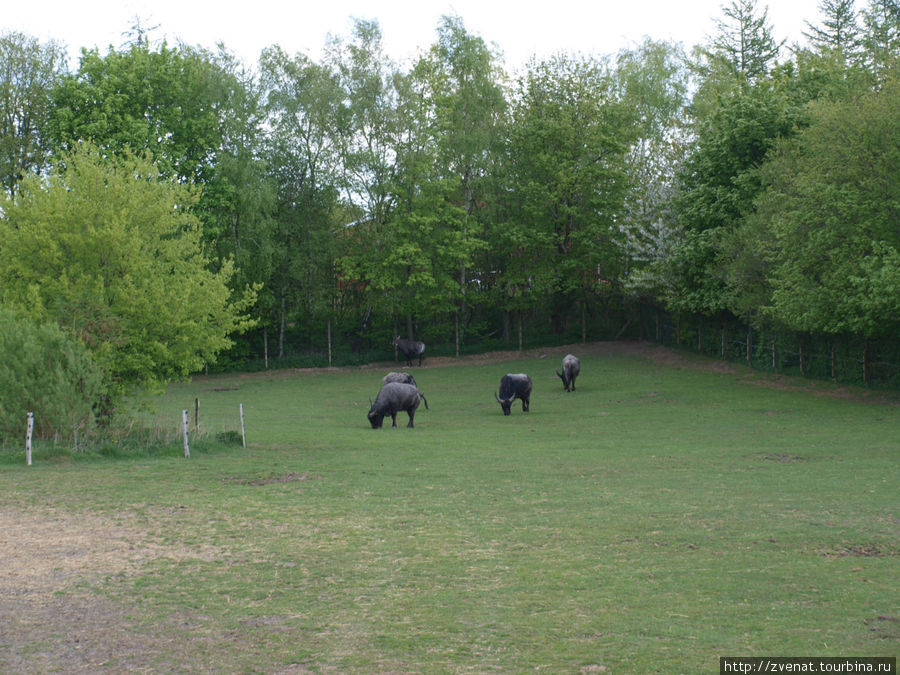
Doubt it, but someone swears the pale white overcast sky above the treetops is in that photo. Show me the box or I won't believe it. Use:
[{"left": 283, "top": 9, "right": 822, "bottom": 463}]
[{"left": 7, "top": 0, "right": 820, "bottom": 69}]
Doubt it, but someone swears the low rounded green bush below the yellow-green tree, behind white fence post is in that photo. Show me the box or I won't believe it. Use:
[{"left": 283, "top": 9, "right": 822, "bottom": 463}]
[{"left": 0, "top": 309, "right": 104, "bottom": 443}]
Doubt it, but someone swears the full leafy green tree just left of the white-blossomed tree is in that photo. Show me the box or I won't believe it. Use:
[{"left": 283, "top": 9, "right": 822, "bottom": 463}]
[{"left": 497, "top": 56, "right": 630, "bottom": 344}]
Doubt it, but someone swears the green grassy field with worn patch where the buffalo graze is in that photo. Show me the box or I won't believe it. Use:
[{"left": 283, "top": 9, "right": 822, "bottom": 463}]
[{"left": 0, "top": 344, "right": 900, "bottom": 673}]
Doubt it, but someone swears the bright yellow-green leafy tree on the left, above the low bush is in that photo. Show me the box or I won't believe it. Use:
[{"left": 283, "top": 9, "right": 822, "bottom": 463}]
[{"left": 0, "top": 144, "right": 254, "bottom": 391}]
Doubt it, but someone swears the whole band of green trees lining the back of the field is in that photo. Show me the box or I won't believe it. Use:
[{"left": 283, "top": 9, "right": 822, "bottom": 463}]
[{"left": 0, "top": 0, "right": 900, "bottom": 440}]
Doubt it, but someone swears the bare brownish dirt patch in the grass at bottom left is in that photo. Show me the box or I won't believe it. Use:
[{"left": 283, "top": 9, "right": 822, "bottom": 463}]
[{"left": 0, "top": 509, "right": 224, "bottom": 673}]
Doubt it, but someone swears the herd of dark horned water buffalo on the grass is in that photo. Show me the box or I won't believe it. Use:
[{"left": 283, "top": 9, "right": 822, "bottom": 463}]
[{"left": 368, "top": 337, "right": 581, "bottom": 429}]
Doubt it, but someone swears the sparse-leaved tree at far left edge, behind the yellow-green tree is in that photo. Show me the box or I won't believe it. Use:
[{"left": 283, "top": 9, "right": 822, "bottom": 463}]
[{"left": 0, "top": 32, "right": 66, "bottom": 195}]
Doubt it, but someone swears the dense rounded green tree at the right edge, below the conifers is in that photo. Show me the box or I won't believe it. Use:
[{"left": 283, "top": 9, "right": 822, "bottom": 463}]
[{"left": 759, "top": 70, "right": 900, "bottom": 338}]
